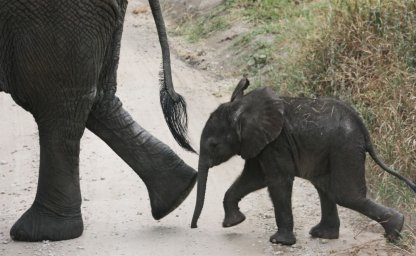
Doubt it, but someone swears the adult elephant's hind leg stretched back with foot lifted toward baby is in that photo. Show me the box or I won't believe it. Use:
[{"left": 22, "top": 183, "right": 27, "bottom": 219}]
[{"left": 87, "top": 94, "right": 196, "bottom": 219}]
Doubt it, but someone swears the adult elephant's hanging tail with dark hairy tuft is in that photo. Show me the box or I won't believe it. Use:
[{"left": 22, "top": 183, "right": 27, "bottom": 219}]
[{"left": 149, "top": 0, "right": 196, "bottom": 153}]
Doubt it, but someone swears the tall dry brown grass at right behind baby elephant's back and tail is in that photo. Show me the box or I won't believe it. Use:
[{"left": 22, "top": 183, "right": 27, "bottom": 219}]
[{"left": 303, "top": 0, "right": 416, "bottom": 248}]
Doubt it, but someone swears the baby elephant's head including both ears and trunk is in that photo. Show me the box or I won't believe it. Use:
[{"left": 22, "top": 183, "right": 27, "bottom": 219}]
[{"left": 191, "top": 78, "right": 283, "bottom": 228}]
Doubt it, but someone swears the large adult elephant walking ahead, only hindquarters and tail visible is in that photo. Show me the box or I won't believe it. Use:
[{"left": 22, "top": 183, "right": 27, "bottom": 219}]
[{"left": 0, "top": 0, "right": 196, "bottom": 241}]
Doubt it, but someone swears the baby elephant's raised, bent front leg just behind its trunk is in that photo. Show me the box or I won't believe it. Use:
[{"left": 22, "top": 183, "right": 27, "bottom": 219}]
[{"left": 222, "top": 159, "right": 266, "bottom": 227}]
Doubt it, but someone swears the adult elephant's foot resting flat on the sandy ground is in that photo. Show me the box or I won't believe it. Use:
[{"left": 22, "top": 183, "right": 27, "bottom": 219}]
[{"left": 10, "top": 202, "right": 84, "bottom": 242}]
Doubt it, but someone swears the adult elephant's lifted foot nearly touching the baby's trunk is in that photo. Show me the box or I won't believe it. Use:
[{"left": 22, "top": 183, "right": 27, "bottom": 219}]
[{"left": 145, "top": 162, "right": 197, "bottom": 220}]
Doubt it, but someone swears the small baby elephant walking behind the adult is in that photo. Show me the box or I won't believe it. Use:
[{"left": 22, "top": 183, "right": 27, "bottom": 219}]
[{"left": 191, "top": 78, "right": 416, "bottom": 245}]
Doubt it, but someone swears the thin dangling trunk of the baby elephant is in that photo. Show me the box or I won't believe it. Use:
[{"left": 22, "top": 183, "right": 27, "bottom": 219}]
[{"left": 191, "top": 160, "right": 208, "bottom": 228}]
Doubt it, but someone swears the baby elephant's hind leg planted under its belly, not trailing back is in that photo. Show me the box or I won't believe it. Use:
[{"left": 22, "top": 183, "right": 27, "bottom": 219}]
[{"left": 309, "top": 186, "right": 340, "bottom": 239}]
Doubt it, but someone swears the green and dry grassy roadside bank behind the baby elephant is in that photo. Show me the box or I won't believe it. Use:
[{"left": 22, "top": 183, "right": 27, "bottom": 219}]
[{"left": 178, "top": 0, "right": 416, "bottom": 252}]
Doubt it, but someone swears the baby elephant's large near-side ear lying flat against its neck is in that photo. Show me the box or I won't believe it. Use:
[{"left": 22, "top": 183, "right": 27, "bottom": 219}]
[{"left": 236, "top": 87, "right": 284, "bottom": 159}]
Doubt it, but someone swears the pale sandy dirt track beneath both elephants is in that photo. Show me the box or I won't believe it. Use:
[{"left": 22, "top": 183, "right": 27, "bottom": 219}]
[{"left": 0, "top": 1, "right": 405, "bottom": 256}]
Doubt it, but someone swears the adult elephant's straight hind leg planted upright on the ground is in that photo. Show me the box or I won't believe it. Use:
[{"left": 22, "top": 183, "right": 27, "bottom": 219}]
[{"left": 10, "top": 97, "right": 92, "bottom": 241}]
